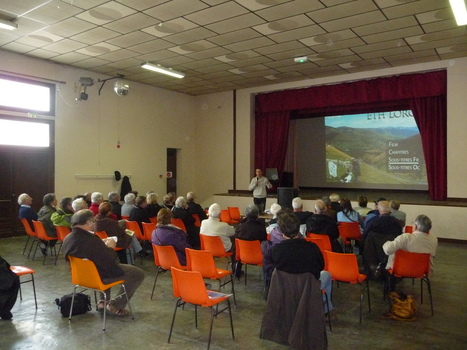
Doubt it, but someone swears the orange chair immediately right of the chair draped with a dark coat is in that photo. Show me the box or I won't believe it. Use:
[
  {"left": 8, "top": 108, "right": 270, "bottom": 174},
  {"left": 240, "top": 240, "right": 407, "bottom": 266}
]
[{"left": 324, "top": 250, "right": 371, "bottom": 323}]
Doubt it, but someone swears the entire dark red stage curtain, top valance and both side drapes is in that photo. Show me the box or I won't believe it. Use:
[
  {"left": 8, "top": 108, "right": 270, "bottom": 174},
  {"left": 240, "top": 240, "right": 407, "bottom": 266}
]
[{"left": 255, "top": 70, "right": 447, "bottom": 200}]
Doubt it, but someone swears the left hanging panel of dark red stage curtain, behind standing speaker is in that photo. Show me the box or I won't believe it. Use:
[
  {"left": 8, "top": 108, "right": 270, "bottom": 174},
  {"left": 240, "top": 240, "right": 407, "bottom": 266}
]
[{"left": 255, "top": 111, "right": 290, "bottom": 176}]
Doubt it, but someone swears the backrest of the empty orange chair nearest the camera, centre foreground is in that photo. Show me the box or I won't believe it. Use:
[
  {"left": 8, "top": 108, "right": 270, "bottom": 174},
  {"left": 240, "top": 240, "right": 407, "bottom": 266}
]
[{"left": 171, "top": 267, "right": 208, "bottom": 305}]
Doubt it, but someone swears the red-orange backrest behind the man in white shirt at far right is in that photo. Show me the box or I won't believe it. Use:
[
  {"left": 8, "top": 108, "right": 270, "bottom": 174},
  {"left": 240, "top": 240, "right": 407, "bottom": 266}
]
[{"left": 392, "top": 250, "right": 430, "bottom": 278}]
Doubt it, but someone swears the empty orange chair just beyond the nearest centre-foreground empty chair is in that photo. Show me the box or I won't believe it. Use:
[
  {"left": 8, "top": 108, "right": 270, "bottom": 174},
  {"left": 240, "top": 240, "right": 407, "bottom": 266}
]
[{"left": 185, "top": 248, "right": 237, "bottom": 306}]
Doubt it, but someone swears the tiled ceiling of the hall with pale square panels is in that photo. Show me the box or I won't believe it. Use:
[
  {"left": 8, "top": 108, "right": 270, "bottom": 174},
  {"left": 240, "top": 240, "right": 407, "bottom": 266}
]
[{"left": 0, "top": 0, "right": 467, "bottom": 95}]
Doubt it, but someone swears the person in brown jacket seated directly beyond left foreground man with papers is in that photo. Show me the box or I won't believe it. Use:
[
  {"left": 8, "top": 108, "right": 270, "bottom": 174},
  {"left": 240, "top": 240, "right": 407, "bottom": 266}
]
[{"left": 95, "top": 202, "right": 142, "bottom": 264}]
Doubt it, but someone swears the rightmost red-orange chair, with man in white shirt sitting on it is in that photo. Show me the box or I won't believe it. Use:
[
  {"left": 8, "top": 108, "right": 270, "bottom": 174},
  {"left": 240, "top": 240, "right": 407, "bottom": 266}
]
[{"left": 384, "top": 250, "right": 435, "bottom": 316}]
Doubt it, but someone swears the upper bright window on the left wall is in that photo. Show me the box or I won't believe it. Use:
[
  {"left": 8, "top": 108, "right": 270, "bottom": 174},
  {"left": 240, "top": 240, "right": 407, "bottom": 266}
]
[{"left": 0, "top": 75, "right": 55, "bottom": 116}]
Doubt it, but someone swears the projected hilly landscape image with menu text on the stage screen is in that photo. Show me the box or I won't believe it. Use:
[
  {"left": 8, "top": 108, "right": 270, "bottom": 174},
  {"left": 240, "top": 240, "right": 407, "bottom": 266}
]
[{"left": 325, "top": 110, "right": 427, "bottom": 188}]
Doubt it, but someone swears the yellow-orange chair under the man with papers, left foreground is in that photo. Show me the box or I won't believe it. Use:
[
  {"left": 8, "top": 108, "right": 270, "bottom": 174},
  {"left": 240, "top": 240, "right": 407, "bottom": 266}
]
[{"left": 68, "top": 255, "right": 135, "bottom": 332}]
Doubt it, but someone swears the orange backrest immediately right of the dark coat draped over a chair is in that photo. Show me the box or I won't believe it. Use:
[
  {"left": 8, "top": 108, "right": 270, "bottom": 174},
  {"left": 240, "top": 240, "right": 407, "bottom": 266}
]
[{"left": 324, "top": 250, "right": 360, "bottom": 283}]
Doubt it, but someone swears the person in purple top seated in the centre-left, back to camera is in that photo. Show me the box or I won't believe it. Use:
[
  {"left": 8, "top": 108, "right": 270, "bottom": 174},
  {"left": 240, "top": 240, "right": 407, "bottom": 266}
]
[{"left": 152, "top": 208, "right": 191, "bottom": 266}]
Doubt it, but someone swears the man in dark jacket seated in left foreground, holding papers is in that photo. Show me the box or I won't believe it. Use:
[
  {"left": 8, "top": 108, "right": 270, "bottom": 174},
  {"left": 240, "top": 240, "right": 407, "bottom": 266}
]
[{"left": 63, "top": 209, "right": 144, "bottom": 316}]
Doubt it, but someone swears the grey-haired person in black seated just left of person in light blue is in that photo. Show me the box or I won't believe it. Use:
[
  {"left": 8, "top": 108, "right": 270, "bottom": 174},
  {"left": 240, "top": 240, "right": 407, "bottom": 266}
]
[{"left": 306, "top": 199, "right": 343, "bottom": 253}]
